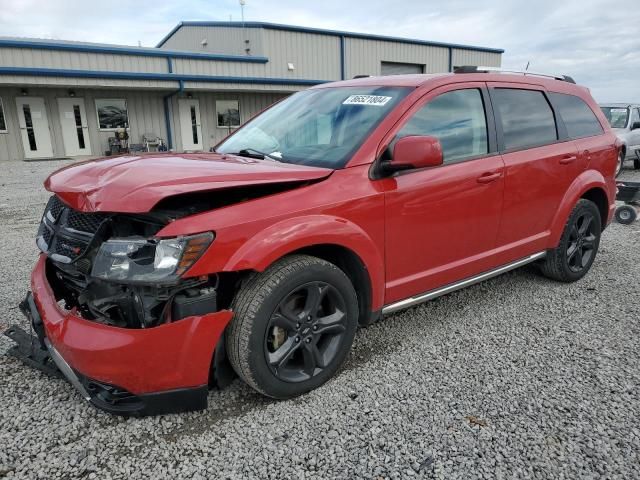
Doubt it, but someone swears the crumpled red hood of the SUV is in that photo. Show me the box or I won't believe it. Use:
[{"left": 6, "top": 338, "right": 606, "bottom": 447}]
[{"left": 44, "top": 153, "right": 333, "bottom": 213}]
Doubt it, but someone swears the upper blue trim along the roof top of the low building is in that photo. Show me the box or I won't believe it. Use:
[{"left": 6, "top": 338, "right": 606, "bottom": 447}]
[{"left": 0, "top": 39, "right": 269, "bottom": 63}]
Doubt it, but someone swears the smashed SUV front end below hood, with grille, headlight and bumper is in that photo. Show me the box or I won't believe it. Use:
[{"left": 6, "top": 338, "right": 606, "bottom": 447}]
[{"left": 5, "top": 195, "right": 239, "bottom": 415}]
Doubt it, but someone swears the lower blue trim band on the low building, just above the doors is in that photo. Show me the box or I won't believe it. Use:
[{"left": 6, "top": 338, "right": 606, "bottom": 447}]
[{"left": 0, "top": 67, "right": 333, "bottom": 86}]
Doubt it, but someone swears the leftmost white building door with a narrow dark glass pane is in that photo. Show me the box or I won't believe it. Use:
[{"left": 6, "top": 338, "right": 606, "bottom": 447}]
[{"left": 16, "top": 97, "right": 53, "bottom": 158}]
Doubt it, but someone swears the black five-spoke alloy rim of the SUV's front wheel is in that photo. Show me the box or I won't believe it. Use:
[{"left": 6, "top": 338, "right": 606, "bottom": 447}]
[{"left": 265, "top": 282, "right": 347, "bottom": 382}]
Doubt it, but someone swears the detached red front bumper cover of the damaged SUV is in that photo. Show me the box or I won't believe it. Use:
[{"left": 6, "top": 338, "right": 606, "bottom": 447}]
[{"left": 31, "top": 255, "right": 232, "bottom": 394}]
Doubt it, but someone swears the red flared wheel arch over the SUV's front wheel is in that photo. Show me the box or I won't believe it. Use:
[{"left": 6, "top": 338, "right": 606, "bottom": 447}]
[{"left": 222, "top": 215, "right": 384, "bottom": 311}]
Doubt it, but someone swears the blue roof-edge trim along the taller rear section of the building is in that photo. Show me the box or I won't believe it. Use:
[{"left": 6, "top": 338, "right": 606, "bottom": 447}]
[{"left": 156, "top": 21, "right": 504, "bottom": 53}]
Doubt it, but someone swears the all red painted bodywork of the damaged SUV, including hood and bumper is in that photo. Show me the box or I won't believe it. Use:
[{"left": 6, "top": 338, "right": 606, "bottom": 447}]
[{"left": 37, "top": 70, "right": 619, "bottom": 393}]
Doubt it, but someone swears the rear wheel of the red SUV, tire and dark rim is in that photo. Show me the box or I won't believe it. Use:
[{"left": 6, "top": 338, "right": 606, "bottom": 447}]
[{"left": 541, "top": 198, "right": 602, "bottom": 282}]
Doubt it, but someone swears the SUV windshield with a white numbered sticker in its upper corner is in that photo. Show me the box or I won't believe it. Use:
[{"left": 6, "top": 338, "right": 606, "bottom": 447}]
[{"left": 216, "top": 86, "right": 410, "bottom": 169}]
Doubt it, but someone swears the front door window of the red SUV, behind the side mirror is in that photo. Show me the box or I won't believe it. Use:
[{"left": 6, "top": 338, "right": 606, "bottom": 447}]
[{"left": 397, "top": 89, "right": 488, "bottom": 163}]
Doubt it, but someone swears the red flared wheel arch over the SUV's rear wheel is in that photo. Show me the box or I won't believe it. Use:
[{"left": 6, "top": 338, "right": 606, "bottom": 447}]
[{"left": 549, "top": 170, "right": 615, "bottom": 248}]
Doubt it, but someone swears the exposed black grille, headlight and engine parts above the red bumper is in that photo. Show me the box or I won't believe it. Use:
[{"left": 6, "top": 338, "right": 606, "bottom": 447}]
[{"left": 37, "top": 195, "right": 224, "bottom": 328}]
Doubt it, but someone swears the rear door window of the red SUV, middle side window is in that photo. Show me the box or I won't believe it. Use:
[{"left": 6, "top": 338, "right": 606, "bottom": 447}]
[{"left": 493, "top": 88, "right": 558, "bottom": 150}]
